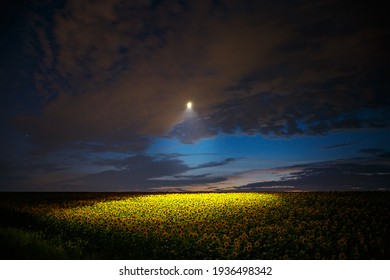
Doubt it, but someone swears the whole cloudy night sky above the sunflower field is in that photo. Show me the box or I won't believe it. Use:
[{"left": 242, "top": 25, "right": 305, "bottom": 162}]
[{"left": 0, "top": 0, "right": 390, "bottom": 191}]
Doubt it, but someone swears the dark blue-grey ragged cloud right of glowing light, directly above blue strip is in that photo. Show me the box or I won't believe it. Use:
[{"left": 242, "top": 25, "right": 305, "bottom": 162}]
[{"left": 184, "top": 80, "right": 390, "bottom": 142}]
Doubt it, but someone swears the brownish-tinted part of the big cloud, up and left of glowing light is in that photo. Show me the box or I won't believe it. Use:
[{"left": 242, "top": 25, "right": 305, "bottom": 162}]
[{"left": 17, "top": 1, "right": 286, "bottom": 149}]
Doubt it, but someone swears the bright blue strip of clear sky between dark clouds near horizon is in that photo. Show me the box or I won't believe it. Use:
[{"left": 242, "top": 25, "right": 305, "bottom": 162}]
[{"left": 147, "top": 131, "right": 390, "bottom": 189}]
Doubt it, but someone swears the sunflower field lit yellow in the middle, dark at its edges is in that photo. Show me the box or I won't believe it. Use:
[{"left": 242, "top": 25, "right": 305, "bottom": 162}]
[{"left": 0, "top": 192, "right": 390, "bottom": 259}]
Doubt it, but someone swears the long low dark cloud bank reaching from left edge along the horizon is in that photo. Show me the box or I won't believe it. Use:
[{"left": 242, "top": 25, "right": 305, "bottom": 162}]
[{"left": 0, "top": 150, "right": 237, "bottom": 191}]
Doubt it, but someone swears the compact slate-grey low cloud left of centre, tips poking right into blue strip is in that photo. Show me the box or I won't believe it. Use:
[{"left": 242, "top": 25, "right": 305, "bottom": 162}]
[{"left": 65, "top": 155, "right": 235, "bottom": 191}]
